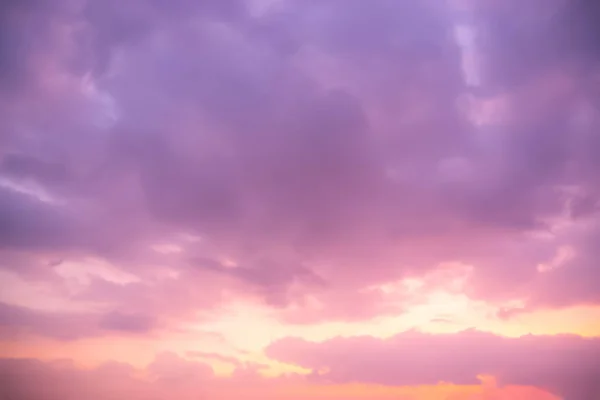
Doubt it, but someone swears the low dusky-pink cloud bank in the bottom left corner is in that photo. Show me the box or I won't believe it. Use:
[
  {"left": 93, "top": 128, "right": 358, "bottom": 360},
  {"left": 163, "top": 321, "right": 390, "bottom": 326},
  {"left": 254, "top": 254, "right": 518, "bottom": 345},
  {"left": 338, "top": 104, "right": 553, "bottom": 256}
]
[{"left": 0, "top": 352, "right": 302, "bottom": 400}]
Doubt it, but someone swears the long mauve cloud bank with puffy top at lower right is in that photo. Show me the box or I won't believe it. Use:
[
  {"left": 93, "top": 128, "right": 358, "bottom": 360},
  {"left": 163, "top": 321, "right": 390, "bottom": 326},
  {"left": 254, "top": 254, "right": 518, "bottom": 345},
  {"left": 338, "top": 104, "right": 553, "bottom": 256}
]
[{"left": 267, "top": 331, "right": 600, "bottom": 400}]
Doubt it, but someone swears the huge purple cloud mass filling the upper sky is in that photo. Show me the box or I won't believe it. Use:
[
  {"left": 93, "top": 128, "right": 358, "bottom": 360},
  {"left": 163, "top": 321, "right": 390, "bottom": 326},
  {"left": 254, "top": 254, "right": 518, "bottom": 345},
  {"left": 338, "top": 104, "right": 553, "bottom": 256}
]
[{"left": 0, "top": 0, "right": 599, "bottom": 331}]
